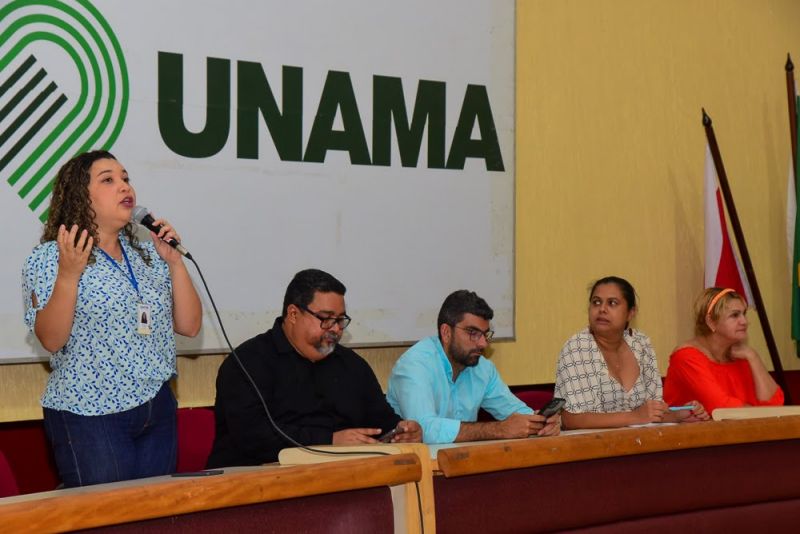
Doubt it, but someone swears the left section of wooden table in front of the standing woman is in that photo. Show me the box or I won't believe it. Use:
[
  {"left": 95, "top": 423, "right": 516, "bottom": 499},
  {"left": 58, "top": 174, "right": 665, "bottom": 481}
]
[{"left": 0, "top": 454, "right": 421, "bottom": 533}]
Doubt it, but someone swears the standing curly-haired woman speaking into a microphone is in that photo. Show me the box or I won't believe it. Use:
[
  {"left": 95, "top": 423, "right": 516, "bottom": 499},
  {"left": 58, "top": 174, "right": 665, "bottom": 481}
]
[{"left": 22, "top": 151, "right": 202, "bottom": 487}]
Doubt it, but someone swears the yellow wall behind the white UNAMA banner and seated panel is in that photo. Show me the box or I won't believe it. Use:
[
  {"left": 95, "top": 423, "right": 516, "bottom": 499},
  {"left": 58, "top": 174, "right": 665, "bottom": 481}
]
[{"left": 0, "top": 0, "right": 800, "bottom": 421}]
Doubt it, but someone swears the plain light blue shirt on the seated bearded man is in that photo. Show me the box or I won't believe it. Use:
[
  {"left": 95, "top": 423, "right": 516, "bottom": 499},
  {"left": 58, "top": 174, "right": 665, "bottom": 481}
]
[{"left": 386, "top": 336, "right": 533, "bottom": 443}]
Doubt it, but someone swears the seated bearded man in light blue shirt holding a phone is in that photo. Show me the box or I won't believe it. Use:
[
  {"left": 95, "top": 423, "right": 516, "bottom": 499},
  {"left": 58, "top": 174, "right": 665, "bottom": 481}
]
[{"left": 387, "top": 289, "right": 561, "bottom": 443}]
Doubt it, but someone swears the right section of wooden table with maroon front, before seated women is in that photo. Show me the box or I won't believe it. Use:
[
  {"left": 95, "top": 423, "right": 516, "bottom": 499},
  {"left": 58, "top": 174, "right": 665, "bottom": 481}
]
[{"left": 434, "top": 416, "right": 800, "bottom": 533}]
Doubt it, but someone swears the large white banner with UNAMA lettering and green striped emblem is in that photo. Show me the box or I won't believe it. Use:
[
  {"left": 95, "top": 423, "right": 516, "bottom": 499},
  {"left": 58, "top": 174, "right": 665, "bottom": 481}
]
[{"left": 0, "top": 0, "right": 515, "bottom": 362}]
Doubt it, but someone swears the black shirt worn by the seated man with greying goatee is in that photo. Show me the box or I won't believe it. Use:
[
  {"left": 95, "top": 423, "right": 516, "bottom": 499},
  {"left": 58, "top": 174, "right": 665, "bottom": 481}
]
[{"left": 208, "top": 317, "right": 401, "bottom": 467}]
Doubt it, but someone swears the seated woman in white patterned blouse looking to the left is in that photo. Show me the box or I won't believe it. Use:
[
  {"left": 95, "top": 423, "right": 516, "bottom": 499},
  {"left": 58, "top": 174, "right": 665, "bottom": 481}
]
[{"left": 555, "top": 276, "right": 708, "bottom": 428}]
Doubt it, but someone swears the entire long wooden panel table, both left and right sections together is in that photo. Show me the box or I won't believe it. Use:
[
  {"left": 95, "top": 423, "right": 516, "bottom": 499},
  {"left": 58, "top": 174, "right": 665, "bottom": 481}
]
[{"left": 6, "top": 416, "right": 800, "bottom": 534}]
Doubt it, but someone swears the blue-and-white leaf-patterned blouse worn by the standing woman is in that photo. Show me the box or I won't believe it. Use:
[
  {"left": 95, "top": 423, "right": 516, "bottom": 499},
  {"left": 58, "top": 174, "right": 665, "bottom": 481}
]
[{"left": 22, "top": 233, "right": 175, "bottom": 415}]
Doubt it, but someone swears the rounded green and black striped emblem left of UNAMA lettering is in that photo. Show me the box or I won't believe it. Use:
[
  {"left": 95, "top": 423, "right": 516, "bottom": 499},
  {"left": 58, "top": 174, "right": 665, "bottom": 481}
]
[{"left": 0, "top": 0, "right": 129, "bottom": 221}]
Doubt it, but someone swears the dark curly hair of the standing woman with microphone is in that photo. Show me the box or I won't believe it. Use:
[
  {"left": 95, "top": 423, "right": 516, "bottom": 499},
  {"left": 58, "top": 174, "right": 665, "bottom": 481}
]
[{"left": 41, "top": 150, "right": 150, "bottom": 265}]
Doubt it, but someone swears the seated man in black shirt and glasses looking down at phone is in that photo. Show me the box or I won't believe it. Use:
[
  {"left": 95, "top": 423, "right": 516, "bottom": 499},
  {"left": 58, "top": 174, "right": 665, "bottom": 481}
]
[{"left": 208, "top": 269, "right": 422, "bottom": 467}]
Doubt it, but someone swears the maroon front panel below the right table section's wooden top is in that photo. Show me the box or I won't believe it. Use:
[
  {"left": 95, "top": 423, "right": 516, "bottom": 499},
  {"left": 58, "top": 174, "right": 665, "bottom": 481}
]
[{"left": 434, "top": 439, "right": 800, "bottom": 534}]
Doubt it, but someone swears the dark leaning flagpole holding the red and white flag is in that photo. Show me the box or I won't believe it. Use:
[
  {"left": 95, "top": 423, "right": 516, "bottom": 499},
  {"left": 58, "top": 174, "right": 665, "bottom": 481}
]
[{"left": 703, "top": 109, "right": 792, "bottom": 404}]
